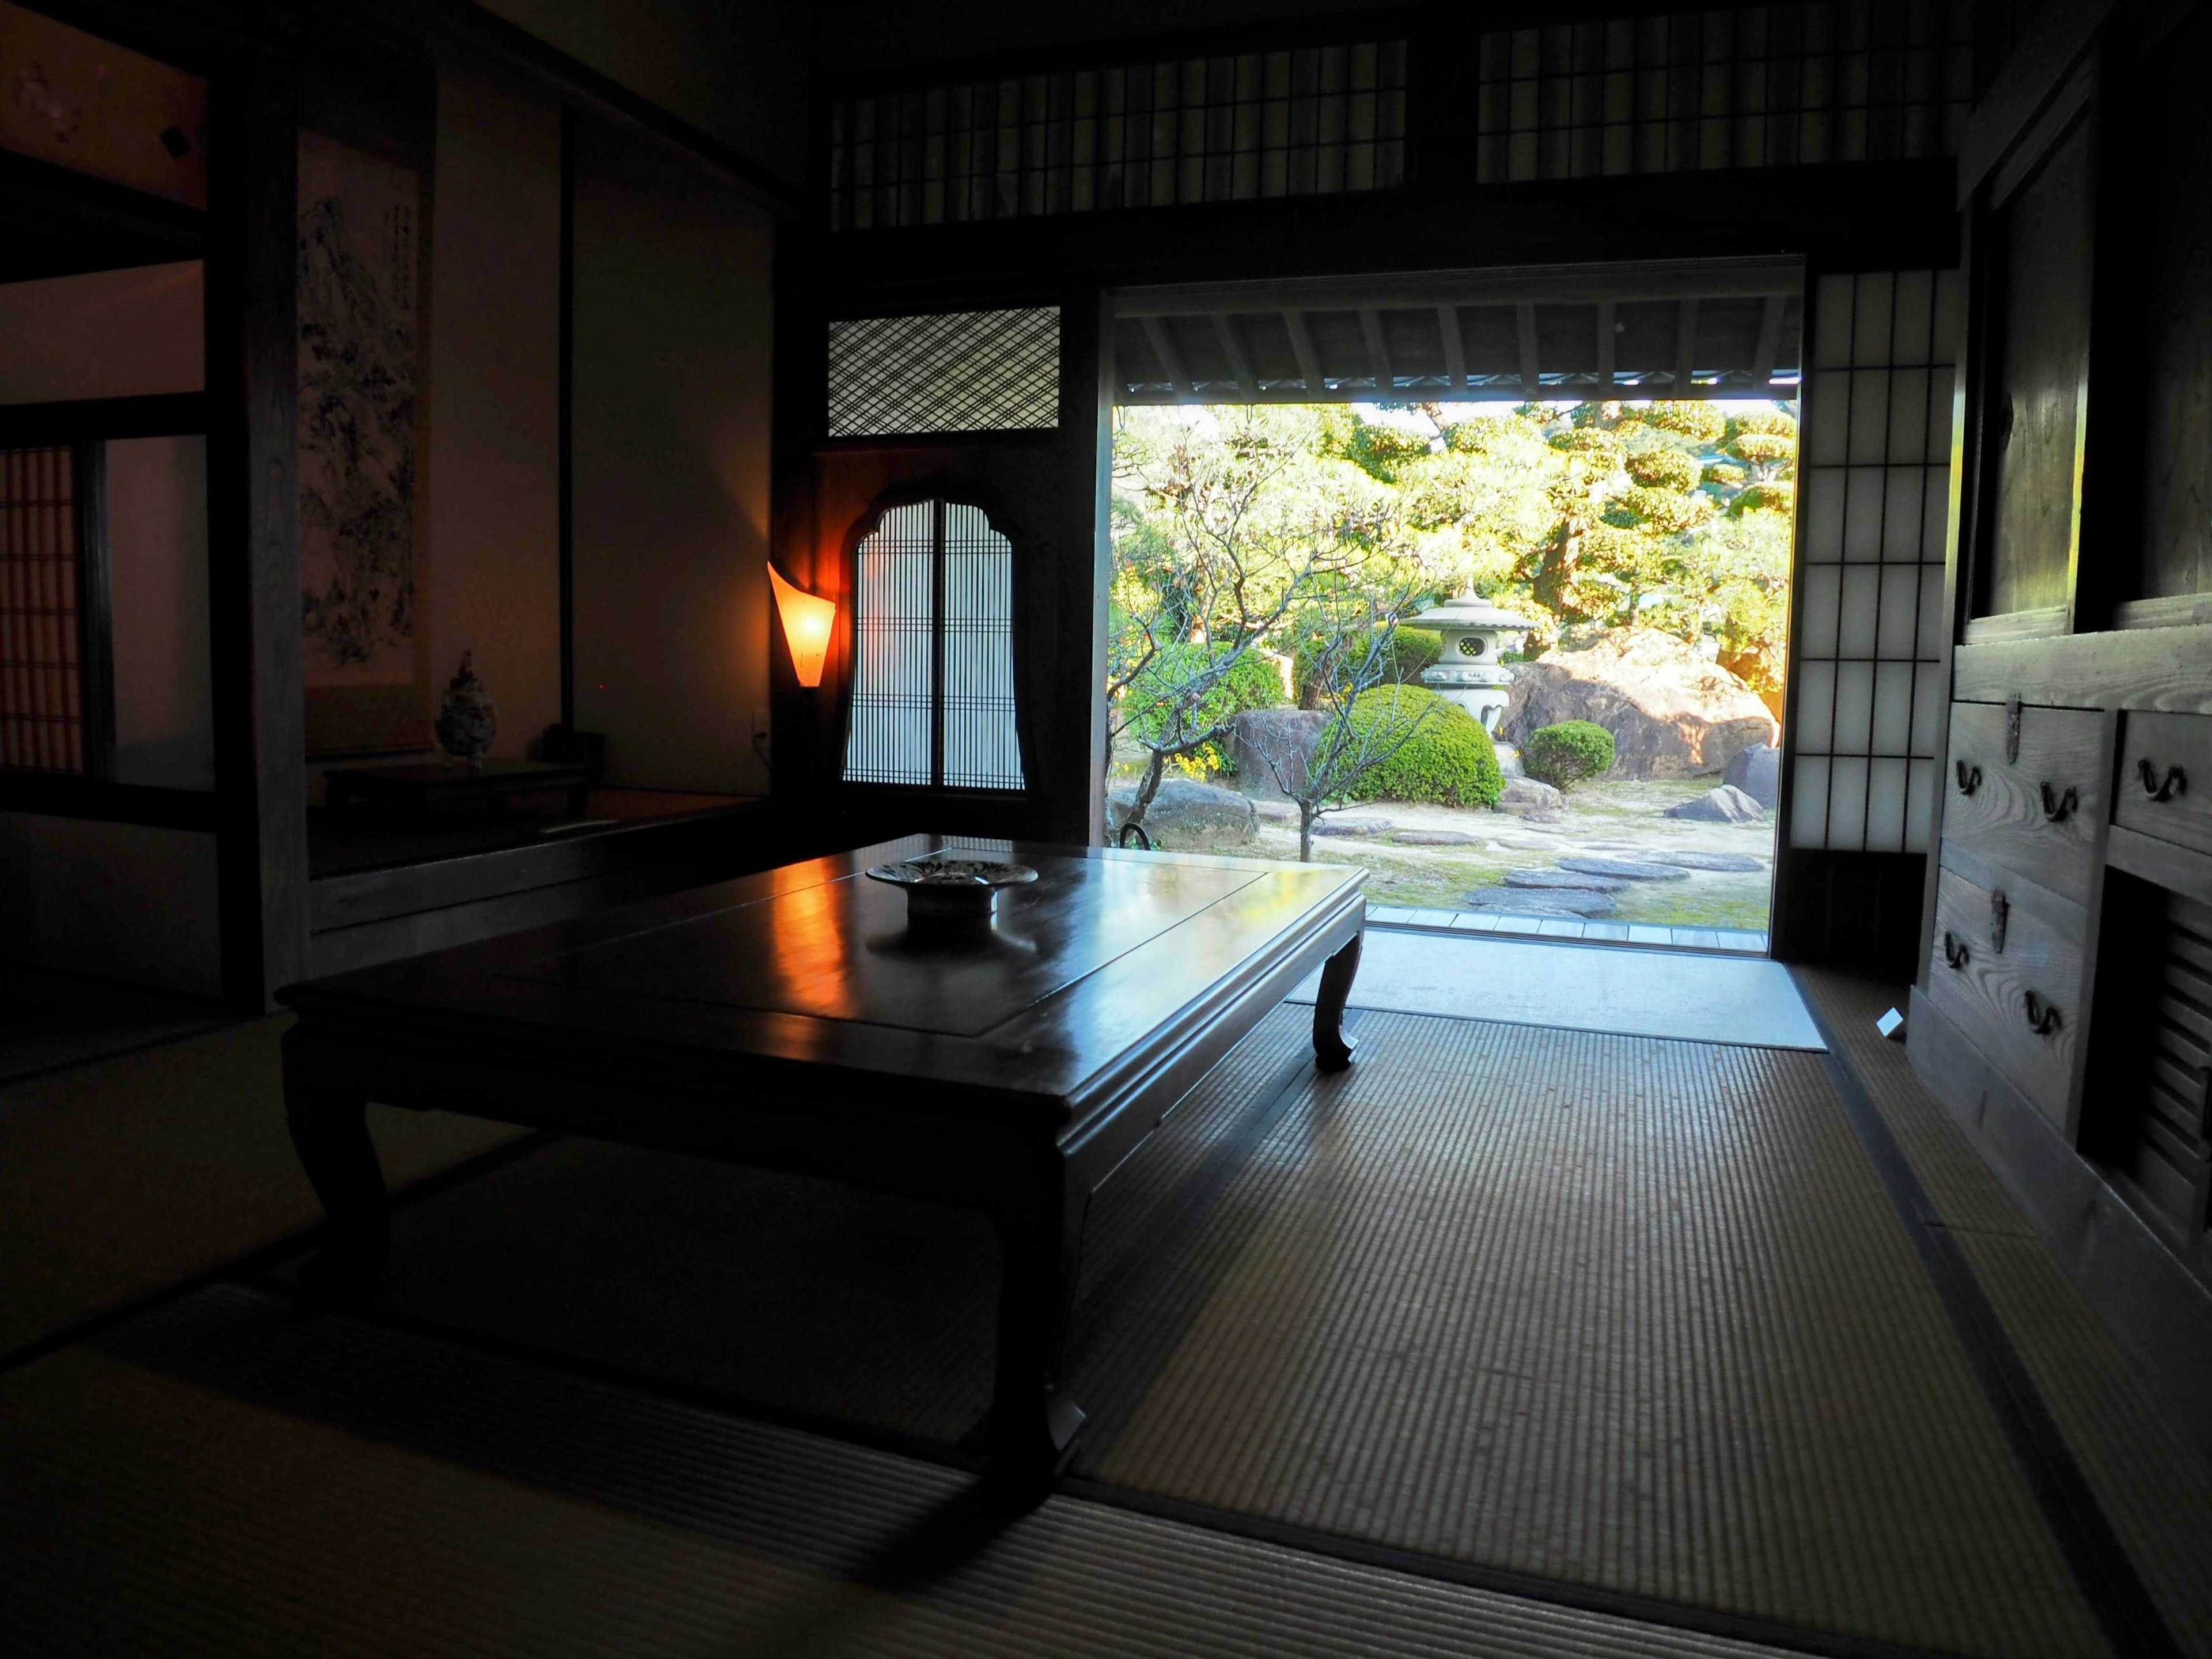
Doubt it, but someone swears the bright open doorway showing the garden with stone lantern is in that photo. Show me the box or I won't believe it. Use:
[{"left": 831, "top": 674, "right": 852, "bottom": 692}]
[{"left": 1108, "top": 391, "right": 1796, "bottom": 951}]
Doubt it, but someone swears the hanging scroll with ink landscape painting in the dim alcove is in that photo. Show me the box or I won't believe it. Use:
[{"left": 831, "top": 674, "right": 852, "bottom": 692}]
[{"left": 298, "top": 131, "right": 429, "bottom": 756}]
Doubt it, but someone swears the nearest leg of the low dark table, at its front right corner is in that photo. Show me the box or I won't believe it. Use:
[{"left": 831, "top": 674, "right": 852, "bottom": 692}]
[{"left": 991, "top": 1159, "right": 1084, "bottom": 1478}]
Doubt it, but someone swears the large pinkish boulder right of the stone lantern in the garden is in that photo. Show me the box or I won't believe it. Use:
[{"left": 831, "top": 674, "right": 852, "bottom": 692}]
[{"left": 1500, "top": 628, "right": 1781, "bottom": 779}]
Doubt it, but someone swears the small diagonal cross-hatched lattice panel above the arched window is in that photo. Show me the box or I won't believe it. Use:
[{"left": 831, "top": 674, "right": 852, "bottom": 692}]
[{"left": 830, "top": 305, "right": 1059, "bottom": 438}]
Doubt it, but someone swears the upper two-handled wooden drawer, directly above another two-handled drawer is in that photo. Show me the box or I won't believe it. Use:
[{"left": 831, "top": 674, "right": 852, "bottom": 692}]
[{"left": 1942, "top": 703, "right": 2105, "bottom": 905}]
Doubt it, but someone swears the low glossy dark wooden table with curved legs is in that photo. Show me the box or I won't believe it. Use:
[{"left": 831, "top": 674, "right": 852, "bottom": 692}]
[{"left": 281, "top": 836, "right": 1367, "bottom": 1469}]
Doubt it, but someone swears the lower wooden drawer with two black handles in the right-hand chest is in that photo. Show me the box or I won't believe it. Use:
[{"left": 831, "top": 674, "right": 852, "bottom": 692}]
[{"left": 1929, "top": 869, "right": 2088, "bottom": 1132}]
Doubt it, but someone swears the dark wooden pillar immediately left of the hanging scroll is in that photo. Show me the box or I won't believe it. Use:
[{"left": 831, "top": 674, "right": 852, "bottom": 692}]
[{"left": 206, "top": 9, "right": 308, "bottom": 1009}]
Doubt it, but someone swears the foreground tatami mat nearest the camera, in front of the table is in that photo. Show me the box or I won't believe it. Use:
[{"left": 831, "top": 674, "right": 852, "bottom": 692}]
[{"left": 0, "top": 1290, "right": 1831, "bottom": 1659}]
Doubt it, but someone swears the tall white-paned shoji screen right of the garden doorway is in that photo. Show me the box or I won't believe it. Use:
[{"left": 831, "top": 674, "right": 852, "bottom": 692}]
[{"left": 1790, "top": 270, "right": 1960, "bottom": 851}]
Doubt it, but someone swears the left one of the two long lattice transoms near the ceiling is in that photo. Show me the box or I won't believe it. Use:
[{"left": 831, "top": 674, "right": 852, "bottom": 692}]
[{"left": 830, "top": 40, "right": 1407, "bottom": 230}]
